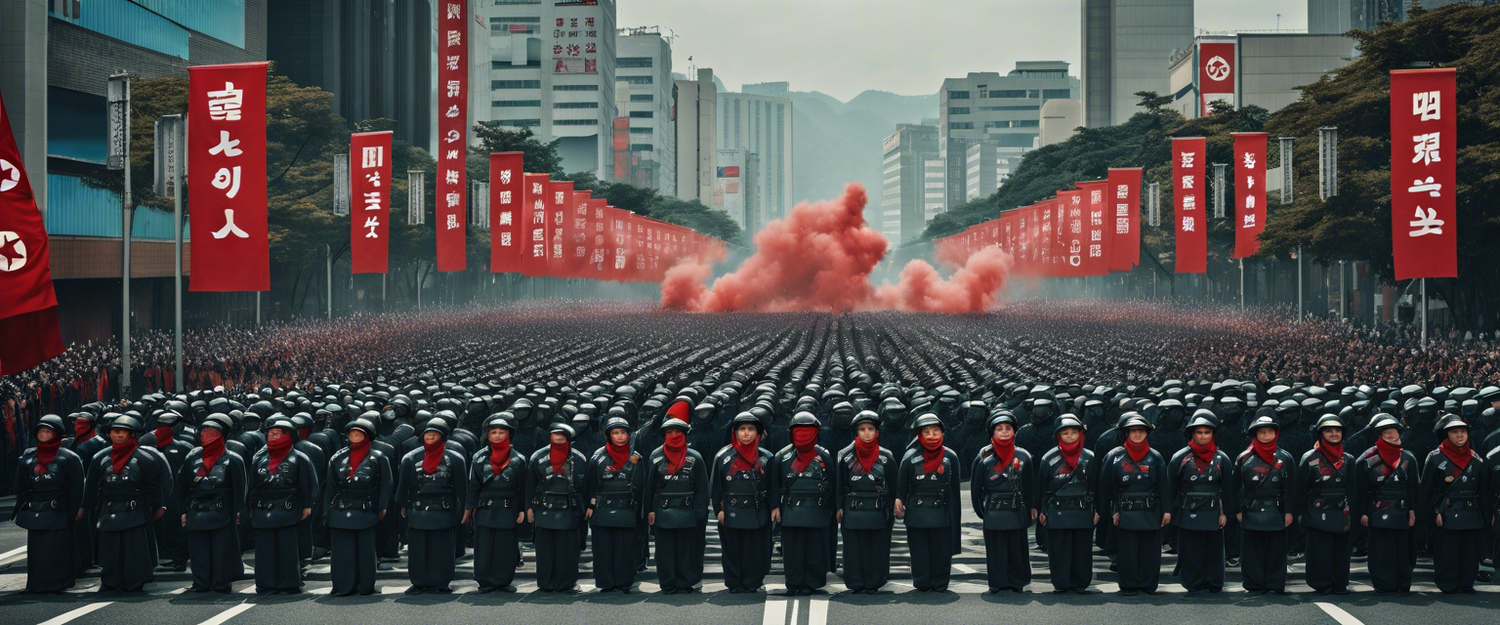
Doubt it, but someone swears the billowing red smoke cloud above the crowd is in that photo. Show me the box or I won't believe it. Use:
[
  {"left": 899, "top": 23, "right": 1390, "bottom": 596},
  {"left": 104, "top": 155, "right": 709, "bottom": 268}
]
[{"left": 662, "top": 184, "right": 1011, "bottom": 312}]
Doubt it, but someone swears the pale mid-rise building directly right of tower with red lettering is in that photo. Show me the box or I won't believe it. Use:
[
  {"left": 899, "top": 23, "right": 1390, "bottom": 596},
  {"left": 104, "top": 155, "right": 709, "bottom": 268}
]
[{"left": 614, "top": 27, "right": 677, "bottom": 196}]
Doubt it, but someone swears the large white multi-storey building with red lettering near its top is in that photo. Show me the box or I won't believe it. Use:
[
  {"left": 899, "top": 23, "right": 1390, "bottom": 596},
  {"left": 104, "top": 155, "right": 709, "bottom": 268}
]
[{"left": 474, "top": 0, "right": 617, "bottom": 180}]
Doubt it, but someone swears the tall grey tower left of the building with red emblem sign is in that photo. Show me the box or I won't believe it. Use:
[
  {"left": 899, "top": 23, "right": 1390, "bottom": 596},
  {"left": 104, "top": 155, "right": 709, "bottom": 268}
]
[{"left": 1080, "top": 0, "right": 1193, "bottom": 127}]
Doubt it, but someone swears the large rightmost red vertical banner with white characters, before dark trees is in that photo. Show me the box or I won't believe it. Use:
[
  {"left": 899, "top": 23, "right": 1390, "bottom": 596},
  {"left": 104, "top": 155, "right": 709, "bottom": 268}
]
[{"left": 1391, "top": 67, "right": 1458, "bottom": 280}]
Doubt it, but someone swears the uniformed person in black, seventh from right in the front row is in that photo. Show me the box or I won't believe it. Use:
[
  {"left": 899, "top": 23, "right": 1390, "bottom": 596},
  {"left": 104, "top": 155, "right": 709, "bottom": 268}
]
[{"left": 1032, "top": 415, "right": 1100, "bottom": 595}]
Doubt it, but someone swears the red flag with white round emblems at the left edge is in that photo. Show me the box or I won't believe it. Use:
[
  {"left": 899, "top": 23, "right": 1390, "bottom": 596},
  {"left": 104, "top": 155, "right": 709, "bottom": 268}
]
[{"left": 0, "top": 90, "right": 65, "bottom": 375}]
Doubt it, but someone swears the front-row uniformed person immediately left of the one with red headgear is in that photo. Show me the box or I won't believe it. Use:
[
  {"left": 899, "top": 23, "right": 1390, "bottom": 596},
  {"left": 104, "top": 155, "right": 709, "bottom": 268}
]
[{"left": 587, "top": 417, "right": 650, "bottom": 595}]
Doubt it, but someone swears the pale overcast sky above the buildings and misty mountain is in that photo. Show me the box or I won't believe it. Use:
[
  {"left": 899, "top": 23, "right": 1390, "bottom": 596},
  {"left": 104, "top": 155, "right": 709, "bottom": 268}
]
[{"left": 618, "top": 0, "right": 1307, "bottom": 100}]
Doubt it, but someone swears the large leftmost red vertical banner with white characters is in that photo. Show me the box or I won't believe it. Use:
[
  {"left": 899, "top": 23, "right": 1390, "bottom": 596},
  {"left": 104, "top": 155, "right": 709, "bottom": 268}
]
[{"left": 186, "top": 63, "right": 272, "bottom": 292}]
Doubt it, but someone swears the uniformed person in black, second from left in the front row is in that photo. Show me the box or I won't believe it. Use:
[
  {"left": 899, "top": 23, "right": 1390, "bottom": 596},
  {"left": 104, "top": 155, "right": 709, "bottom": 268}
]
[{"left": 84, "top": 415, "right": 167, "bottom": 592}]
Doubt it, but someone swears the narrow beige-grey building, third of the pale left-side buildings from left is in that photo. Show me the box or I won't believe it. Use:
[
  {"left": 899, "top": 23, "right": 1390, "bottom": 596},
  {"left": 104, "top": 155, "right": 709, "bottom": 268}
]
[{"left": 674, "top": 69, "right": 719, "bottom": 205}]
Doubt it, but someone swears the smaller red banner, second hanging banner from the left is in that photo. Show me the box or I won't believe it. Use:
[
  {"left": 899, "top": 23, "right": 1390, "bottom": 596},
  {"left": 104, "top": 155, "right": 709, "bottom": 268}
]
[{"left": 350, "top": 130, "right": 392, "bottom": 273}]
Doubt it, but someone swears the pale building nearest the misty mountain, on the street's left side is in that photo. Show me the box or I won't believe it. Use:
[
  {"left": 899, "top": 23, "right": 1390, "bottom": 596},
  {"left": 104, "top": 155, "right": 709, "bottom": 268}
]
[{"left": 719, "top": 87, "right": 792, "bottom": 223}]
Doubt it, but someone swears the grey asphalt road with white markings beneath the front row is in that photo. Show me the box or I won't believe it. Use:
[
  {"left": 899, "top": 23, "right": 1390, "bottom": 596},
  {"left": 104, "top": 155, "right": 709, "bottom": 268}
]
[{"left": 0, "top": 485, "right": 1500, "bottom": 625}]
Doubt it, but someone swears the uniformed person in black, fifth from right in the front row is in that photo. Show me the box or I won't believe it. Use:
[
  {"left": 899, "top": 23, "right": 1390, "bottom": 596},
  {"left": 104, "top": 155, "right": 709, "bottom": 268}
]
[{"left": 1167, "top": 411, "right": 1233, "bottom": 595}]
